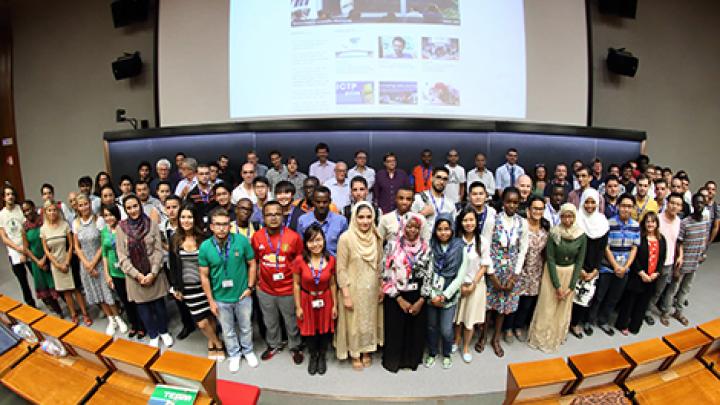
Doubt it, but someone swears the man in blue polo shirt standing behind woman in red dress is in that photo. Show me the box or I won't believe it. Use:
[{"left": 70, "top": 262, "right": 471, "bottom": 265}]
[{"left": 298, "top": 186, "right": 346, "bottom": 256}]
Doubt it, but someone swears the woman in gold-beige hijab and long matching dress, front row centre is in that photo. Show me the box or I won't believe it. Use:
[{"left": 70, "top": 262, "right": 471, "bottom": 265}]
[{"left": 335, "top": 201, "right": 385, "bottom": 370}]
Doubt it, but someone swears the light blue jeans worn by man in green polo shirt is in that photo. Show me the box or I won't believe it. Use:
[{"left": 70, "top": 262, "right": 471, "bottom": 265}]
[{"left": 216, "top": 297, "right": 253, "bottom": 357}]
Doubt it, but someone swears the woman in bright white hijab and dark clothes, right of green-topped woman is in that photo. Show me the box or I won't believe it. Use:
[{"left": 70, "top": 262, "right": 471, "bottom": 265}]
[{"left": 570, "top": 187, "right": 610, "bottom": 339}]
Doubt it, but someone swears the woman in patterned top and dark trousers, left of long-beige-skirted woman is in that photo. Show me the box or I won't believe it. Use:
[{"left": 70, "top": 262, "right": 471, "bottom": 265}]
[{"left": 503, "top": 196, "right": 548, "bottom": 343}]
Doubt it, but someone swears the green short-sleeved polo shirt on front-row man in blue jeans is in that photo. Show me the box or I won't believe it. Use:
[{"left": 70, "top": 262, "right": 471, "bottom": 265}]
[{"left": 198, "top": 233, "right": 255, "bottom": 303}]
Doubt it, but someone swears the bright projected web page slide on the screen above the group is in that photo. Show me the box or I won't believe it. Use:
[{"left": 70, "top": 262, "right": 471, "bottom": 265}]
[{"left": 228, "top": 0, "right": 527, "bottom": 119}]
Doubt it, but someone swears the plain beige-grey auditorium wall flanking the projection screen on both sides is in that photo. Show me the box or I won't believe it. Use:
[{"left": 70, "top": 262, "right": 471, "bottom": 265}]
[{"left": 12, "top": 0, "right": 720, "bottom": 199}]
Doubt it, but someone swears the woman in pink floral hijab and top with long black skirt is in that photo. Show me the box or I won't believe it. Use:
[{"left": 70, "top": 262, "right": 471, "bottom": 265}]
[{"left": 382, "top": 212, "right": 431, "bottom": 373}]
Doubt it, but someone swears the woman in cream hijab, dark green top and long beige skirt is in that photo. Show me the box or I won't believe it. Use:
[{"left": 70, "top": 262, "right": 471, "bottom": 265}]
[{"left": 528, "top": 203, "right": 587, "bottom": 353}]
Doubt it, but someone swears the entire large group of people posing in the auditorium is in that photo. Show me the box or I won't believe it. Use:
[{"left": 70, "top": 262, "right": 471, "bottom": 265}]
[{"left": 0, "top": 144, "right": 720, "bottom": 375}]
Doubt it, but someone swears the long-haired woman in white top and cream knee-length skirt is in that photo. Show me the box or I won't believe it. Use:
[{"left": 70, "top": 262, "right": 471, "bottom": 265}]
[{"left": 454, "top": 206, "right": 492, "bottom": 363}]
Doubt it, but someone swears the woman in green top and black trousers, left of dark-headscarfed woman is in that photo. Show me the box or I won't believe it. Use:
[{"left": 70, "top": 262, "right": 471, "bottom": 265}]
[{"left": 100, "top": 204, "right": 145, "bottom": 339}]
